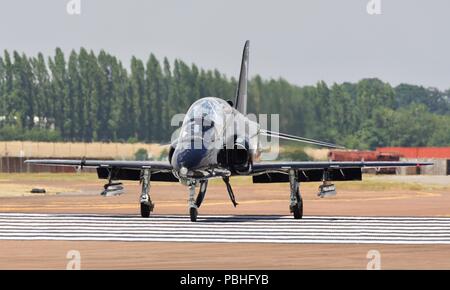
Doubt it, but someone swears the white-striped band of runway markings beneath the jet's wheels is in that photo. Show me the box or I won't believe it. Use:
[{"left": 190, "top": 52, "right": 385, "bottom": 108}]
[{"left": 0, "top": 213, "right": 450, "bottom": 244}]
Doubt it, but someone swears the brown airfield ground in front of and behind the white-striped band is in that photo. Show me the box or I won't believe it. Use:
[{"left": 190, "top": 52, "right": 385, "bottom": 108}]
[{"left": 0, "top": 173, "right": 450, "bottom": 269}]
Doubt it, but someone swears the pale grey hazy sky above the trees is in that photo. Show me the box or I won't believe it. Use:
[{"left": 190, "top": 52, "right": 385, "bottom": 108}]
[{"left": 0, "top": 0, "right": 450, "bottom": 89}]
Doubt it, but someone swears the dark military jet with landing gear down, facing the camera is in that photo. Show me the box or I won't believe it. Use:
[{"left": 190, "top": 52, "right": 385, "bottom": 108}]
[{"left": 25, "top": 41, "right": 431, "bottom": 222}]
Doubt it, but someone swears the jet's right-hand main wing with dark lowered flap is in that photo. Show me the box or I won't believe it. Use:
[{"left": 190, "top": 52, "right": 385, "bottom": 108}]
[{"left": 251, "top": 161, "right": 433, "bottom": 183}]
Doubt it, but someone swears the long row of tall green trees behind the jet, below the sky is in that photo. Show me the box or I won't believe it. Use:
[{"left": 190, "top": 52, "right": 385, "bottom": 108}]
[{"left": 0, "top": 48, "right": 450, "bottom": 149}]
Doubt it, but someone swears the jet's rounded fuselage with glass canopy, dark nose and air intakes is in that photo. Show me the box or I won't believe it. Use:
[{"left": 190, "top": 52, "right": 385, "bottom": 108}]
[{"left": 169, "top": 97, "right": 260, "bottom": 181}]
